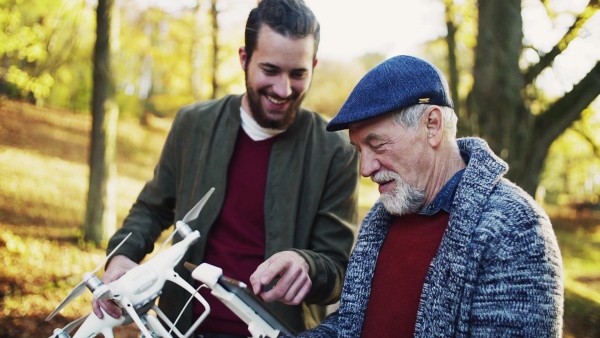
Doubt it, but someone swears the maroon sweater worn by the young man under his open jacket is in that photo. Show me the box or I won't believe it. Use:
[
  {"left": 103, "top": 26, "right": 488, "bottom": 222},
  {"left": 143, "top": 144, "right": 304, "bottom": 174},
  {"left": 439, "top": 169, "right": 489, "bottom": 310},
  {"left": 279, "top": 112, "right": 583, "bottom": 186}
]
[{"left": 194, "top": 128, "right": 277, "bottom": 336}]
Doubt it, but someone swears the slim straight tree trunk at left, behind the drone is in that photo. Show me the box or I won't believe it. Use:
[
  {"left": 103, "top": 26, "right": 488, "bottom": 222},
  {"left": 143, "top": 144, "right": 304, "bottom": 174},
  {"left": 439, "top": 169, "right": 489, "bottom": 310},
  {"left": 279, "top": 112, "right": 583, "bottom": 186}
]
[{"left": 83, "top": 0, "right": 119, "bottom": 245}]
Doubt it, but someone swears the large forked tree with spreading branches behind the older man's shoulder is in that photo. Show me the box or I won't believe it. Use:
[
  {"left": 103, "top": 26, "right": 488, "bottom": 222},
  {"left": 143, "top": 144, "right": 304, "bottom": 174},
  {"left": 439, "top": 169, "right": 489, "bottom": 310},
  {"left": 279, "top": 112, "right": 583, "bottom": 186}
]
[{"left": 445, "top": 0, "right": 600, "bottom": 194}]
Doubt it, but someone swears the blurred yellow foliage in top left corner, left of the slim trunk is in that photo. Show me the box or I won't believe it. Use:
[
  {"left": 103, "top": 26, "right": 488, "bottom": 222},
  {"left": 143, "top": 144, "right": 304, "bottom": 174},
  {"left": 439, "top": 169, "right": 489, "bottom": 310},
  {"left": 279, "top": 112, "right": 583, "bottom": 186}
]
[{"left": 0, "top": 0, "right": 95, "bottom": 110}]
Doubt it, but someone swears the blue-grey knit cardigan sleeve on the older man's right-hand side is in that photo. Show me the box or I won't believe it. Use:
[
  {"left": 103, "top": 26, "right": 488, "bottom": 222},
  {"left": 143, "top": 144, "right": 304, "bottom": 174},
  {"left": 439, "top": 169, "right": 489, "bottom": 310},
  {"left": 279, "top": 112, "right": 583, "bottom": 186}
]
[{"left": 470, "top": 189, "right": 564, "bottom": 337}]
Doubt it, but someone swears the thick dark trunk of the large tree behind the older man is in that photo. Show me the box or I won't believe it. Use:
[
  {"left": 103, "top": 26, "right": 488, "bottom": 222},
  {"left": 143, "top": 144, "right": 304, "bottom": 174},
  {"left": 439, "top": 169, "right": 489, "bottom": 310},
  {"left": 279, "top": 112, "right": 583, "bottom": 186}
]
[{"left": 468, "top": 0, "right": 538, "bottom": 193}]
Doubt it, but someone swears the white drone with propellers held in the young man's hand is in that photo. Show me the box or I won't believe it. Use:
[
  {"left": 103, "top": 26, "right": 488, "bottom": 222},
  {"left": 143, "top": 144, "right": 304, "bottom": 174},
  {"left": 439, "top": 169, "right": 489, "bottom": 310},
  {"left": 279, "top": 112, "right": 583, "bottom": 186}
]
[{"left": 46, "top": 188, "right": 214, "bottom": 338}]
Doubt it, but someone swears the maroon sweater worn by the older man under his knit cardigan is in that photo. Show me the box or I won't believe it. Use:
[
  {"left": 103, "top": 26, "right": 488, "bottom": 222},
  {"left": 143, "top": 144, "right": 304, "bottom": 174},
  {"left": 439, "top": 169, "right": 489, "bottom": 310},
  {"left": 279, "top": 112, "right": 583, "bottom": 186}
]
[{"left": 362, "top": 210, "right": 450, "bottom": 337}]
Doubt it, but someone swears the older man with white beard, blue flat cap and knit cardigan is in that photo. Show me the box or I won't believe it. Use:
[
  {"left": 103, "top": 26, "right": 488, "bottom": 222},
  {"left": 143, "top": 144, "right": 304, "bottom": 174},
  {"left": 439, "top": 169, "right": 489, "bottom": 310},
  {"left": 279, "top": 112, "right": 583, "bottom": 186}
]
[{"left": 292, "top": 56, "right": 563, "bottom": 337}]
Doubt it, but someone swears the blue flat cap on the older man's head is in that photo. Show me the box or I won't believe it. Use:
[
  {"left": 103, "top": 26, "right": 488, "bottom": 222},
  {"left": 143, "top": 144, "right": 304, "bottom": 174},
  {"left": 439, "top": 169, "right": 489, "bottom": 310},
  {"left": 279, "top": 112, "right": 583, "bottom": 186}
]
[{"left": 326, "top": 55, "right": 454, "bottom": 131}]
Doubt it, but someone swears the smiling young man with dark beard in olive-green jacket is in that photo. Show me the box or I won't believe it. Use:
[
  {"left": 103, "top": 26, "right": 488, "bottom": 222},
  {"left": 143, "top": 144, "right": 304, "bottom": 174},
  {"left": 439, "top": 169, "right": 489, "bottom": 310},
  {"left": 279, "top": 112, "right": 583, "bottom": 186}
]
[{"left": 94, "top": 0, "right": 358, "bottom": 337}]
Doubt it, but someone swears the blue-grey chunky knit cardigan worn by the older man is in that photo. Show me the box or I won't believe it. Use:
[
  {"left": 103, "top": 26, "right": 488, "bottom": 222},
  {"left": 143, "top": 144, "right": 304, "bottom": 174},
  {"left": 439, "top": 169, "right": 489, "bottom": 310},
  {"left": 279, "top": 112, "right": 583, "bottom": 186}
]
[{"left": 292, "top": 138, "right": 564, "bottom": 338}]
